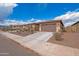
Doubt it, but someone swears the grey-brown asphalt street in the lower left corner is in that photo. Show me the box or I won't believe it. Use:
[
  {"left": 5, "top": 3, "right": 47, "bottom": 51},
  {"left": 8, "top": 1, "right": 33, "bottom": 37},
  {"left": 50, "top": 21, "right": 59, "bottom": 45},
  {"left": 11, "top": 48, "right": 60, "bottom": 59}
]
[{"left": 0, "top": 34, "right": 38, "bottom": 56}]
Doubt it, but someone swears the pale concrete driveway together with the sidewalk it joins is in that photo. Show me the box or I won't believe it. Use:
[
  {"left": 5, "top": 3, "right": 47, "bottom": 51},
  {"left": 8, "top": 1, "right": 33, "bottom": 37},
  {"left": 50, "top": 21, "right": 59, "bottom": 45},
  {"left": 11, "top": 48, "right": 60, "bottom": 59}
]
[{"left": 2, "top": 32, "right": 79, "bottom": 56}]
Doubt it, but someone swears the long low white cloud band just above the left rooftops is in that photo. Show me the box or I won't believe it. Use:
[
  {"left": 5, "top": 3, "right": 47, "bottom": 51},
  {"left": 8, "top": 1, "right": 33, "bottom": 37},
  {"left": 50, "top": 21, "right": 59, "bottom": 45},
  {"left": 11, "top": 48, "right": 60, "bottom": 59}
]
[{"left": 0, "top": 18, "right": 44, "bottom": 25}]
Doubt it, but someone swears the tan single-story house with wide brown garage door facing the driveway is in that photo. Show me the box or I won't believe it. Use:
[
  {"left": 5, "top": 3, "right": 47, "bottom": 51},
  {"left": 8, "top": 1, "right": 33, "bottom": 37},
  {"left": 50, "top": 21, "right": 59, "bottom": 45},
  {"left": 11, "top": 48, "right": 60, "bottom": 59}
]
[{"left": 30, "top": 20, "right": 64, "bottom": 32}]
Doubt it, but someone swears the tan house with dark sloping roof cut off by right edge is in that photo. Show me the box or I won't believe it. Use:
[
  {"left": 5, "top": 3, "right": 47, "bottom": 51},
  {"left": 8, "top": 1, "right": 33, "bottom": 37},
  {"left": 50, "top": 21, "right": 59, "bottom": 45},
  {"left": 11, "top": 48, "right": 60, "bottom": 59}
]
[{"left": 65, "top": 21, "right": 79, "bottom": 32}]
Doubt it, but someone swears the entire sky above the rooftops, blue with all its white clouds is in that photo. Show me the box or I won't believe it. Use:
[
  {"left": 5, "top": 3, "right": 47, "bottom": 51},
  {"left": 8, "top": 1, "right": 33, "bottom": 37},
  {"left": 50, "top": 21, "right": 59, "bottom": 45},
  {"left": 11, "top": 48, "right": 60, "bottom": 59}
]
[{"left": 0, "top": 3, "right": 79, "bottom": 26}]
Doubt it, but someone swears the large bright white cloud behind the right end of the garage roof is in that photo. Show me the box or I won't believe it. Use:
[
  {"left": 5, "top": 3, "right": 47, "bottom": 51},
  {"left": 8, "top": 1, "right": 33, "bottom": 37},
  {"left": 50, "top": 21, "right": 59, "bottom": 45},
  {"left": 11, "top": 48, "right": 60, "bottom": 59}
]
[{"left": 54, "top": 9, "right": 79, "bottom": 26}]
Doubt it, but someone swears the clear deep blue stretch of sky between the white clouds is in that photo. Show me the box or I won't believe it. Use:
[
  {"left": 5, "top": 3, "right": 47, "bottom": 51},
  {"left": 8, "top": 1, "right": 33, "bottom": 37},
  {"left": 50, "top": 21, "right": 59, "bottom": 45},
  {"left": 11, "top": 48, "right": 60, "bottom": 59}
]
[{"left": 8, "top": 3, "right": 79, "bottom": 20}]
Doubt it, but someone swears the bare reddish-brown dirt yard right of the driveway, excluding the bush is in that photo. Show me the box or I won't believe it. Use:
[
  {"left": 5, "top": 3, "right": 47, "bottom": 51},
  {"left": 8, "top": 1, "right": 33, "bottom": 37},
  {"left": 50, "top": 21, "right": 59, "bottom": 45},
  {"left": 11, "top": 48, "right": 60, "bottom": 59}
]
[{"left": 48, "top": 33, "right": 79, "bottom": 49}]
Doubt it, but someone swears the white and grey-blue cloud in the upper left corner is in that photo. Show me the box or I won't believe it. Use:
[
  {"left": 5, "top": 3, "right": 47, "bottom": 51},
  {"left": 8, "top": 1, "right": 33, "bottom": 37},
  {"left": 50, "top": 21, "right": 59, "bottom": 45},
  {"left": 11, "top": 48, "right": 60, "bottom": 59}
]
[{"left": 0, "top": 3, "right": 18, "bottom": 19}]
